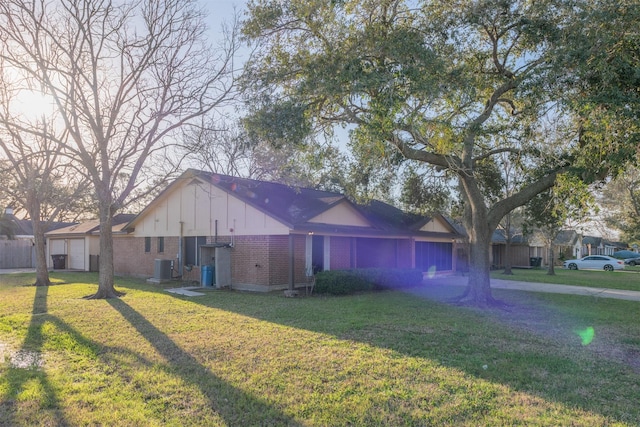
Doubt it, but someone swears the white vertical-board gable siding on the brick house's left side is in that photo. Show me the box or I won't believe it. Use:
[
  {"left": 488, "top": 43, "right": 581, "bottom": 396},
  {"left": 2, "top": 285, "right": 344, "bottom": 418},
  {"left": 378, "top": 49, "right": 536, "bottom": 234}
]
[{"left": 134, "top": 180, "right": 289, "bottom": 237}]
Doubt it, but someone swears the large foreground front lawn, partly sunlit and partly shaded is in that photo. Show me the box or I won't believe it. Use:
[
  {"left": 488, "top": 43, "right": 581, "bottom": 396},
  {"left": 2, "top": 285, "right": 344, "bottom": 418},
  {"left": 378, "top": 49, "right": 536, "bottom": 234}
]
[{"left": 0, "top": 273, "right": 640, "bottom": 426}]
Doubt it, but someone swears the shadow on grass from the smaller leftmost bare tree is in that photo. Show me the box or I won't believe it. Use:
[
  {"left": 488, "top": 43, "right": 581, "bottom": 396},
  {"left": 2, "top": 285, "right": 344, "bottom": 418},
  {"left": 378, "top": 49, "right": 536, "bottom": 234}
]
[{"left": 0, "top": 286, "right": 68, "bottom": 425}]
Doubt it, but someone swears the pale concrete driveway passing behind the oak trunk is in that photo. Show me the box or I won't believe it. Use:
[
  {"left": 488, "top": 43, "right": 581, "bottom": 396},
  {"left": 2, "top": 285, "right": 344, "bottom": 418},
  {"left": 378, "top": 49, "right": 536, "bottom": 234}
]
[{"left": 425, "top": 276, "right": 640, "bottom": 301}]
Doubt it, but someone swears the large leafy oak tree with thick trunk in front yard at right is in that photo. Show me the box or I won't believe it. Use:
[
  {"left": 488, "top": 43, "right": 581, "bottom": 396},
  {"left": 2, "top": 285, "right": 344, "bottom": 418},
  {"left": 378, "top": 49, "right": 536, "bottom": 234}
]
[{"left": 244, "top": 0, "right": 640, "bottom": 305}]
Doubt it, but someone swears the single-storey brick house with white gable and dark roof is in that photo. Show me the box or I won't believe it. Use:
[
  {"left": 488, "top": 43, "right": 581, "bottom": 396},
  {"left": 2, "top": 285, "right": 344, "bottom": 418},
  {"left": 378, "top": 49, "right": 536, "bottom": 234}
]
[{"left": 114, "top": 170, "right": 459, "bottom": 291}]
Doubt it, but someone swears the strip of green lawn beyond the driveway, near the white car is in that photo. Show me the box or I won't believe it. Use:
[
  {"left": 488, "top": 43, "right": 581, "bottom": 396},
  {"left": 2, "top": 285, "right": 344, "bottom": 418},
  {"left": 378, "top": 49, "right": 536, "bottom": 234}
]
[{"left": 491, "top": 267, "right": 640, "bottom": 291}]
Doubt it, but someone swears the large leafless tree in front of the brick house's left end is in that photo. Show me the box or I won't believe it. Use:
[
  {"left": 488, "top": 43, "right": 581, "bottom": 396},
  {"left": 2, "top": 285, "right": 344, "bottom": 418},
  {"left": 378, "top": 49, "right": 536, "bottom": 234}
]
[{"left": 0, "top": 0, "right": 237, "bottom": 298}]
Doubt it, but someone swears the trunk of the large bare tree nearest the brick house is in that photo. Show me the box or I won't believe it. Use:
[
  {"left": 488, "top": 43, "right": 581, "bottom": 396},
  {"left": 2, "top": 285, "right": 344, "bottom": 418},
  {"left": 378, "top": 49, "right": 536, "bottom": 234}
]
[{"left": 87, "top": 199, "right": 124, "bottom": 299}]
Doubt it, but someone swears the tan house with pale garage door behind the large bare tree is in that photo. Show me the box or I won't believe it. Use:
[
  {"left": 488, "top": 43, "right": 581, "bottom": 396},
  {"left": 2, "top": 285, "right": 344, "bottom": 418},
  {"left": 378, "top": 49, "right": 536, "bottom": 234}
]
[{"left": 45, "top": 214, "right": 135, "bottom": 271}]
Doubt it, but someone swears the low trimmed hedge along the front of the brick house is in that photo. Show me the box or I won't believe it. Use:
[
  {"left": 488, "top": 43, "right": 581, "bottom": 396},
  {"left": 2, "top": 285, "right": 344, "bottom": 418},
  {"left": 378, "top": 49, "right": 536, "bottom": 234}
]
[{"left": 315, "top": 268, "right": 422, "bottom": 295}]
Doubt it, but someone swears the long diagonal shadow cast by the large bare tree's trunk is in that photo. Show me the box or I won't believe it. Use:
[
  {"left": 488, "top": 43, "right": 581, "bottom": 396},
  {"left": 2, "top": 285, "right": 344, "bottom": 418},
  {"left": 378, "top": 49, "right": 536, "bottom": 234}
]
[{"left": 108, "top": 299, "right": 299, "bottom": 426}]
